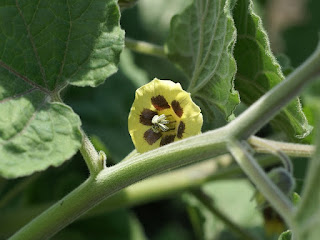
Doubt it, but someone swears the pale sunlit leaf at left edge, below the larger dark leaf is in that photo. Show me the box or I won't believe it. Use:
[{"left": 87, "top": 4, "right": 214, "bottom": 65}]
[{"left": 0, "top": 94, "right": 81, "bottom": 178}]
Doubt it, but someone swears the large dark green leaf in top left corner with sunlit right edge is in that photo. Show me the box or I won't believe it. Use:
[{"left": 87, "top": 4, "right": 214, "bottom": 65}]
[{"left": 0, "top": 0, "right": 123, "bottom": 88}]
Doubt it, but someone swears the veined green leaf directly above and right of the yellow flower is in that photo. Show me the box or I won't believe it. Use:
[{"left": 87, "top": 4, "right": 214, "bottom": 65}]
[{"left": 166, "top": 0, "right": 239, "bottom": 117}]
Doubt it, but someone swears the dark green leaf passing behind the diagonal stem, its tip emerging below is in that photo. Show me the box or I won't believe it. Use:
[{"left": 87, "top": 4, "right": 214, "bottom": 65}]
[{"left": 233, "top": 0, "right": 312, "bottom": 138}]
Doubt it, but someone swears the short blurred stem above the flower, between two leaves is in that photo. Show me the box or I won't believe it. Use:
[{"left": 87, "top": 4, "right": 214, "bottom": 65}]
[{"left": 125, "top": 38, "right": 166, "bottom": 57}]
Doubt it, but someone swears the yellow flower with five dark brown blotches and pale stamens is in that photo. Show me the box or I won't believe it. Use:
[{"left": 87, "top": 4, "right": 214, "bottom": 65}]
[{"left": 128, "top": 78, "right": 203, "bottom": 153}]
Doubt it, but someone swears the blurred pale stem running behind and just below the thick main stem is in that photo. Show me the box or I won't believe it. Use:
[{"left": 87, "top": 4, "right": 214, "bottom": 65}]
[{"left": 0, "top": 154, "right": 279, "bottom": 235}]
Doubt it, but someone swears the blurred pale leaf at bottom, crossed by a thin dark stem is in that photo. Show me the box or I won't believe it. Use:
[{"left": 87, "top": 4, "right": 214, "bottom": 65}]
[{"left": 184, "top": 180, "right": 269, "bottom": 240}]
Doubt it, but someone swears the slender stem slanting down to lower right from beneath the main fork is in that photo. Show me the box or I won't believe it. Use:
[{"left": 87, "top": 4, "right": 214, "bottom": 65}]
[{"left": 228, "top": 140, "right": 293, "bottom": 226}]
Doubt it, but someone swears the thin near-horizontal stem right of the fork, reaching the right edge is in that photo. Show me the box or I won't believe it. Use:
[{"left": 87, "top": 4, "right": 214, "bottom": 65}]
[{"left": 248, "top": 136, "right": 315, "bottom": 157}]
